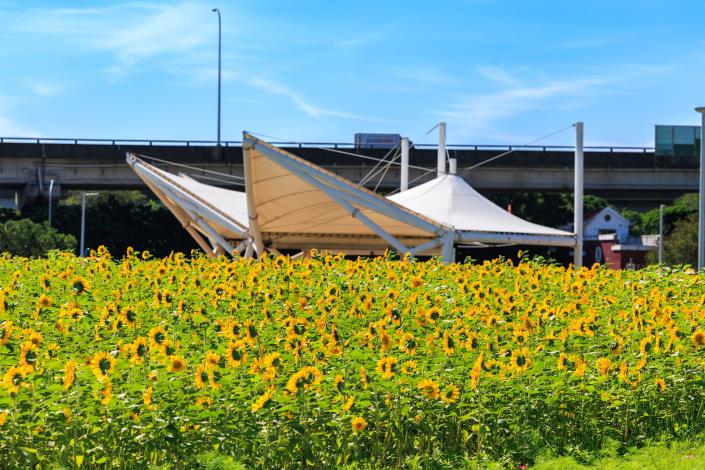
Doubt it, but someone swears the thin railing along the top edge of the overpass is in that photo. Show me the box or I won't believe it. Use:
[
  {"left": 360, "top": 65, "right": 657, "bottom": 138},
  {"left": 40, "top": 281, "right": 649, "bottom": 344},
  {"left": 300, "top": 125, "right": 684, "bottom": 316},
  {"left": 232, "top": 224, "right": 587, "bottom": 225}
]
[{"left": 0, "top": 137, "right": 654, "bottom": 153}]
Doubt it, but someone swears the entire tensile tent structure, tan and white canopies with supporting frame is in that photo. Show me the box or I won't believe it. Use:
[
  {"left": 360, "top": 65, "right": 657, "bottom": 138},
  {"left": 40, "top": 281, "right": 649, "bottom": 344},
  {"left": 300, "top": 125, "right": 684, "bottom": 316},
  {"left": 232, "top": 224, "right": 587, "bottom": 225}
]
[{"left": 127, "top": 129, "right": 576, "bottom": 261}]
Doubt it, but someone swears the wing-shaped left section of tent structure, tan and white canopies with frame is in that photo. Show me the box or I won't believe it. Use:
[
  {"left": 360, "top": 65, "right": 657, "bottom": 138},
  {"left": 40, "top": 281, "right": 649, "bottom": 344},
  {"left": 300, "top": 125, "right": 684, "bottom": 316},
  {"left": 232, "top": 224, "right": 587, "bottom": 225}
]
[{"left": 127, "top": 133, "right": 453, "bottom": 259}]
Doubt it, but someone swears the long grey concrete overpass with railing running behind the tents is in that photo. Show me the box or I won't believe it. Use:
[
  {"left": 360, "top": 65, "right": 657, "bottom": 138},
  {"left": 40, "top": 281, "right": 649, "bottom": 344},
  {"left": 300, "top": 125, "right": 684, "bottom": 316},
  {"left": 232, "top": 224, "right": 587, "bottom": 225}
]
[{"left": 0, "top": 138, "right": 699, "bottom": 207}]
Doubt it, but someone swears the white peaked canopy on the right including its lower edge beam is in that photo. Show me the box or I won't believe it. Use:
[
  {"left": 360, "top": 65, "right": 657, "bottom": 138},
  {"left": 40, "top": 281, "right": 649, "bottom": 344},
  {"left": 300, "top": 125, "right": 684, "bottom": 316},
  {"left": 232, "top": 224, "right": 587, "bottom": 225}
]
[{"left": 389, "top": 174, "right": 575, "bottom": 246}]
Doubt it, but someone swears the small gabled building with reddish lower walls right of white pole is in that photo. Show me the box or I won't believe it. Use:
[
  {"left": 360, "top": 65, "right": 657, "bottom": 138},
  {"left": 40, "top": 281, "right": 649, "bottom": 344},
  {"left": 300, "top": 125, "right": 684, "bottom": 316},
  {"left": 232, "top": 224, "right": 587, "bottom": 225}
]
[{"left": 561, "top": 207, "right": 658, "bottom": 269}]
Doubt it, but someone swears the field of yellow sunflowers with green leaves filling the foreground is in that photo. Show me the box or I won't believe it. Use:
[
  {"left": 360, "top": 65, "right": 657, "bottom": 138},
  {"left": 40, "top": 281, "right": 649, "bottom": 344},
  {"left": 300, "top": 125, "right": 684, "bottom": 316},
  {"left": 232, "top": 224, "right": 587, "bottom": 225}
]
[{"left": 0, "top": 250, "right": 705, "bottom": 468}]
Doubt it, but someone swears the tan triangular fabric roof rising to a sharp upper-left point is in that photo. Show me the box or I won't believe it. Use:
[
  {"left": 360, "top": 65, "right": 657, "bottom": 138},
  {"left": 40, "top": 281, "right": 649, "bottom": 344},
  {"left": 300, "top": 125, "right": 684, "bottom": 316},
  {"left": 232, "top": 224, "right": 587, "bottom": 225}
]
[{"left": 244, "top": 134, "right": 443, "bottom": 238}]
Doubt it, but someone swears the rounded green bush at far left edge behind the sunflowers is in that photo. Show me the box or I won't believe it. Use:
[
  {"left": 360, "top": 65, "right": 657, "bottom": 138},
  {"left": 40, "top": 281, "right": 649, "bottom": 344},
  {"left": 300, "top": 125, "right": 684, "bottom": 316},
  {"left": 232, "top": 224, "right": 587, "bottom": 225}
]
[{"left": 0, "top": 219, "right": 76, "bottom": 257}]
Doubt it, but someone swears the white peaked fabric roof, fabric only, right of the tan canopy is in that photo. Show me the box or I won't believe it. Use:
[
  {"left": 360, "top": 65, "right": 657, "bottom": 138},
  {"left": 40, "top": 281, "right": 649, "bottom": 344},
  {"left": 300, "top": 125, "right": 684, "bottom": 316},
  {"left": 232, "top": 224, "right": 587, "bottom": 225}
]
[{"left": 389, "top": 175, "right": 573, "bottom": 237}]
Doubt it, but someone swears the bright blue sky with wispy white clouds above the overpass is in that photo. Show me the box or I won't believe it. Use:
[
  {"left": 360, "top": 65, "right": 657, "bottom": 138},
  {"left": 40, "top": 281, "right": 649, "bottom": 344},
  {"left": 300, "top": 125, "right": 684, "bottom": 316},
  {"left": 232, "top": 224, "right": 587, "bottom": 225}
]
[{"left": 0, "top": 0, "right": 705, "bottom": 146}]
